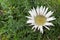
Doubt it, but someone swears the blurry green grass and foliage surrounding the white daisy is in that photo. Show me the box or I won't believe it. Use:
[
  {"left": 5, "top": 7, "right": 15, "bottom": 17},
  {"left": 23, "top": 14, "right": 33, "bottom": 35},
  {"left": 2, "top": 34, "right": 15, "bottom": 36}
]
[{"left": 0, "top": 0, "right": 60, "bottom": 40}]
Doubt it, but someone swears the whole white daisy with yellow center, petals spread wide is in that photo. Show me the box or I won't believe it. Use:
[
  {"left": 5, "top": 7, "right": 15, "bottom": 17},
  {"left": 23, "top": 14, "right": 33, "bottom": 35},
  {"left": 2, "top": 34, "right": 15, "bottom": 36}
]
[{"left": 27, "top": 6, "right": 56, "bottom": 33}]
